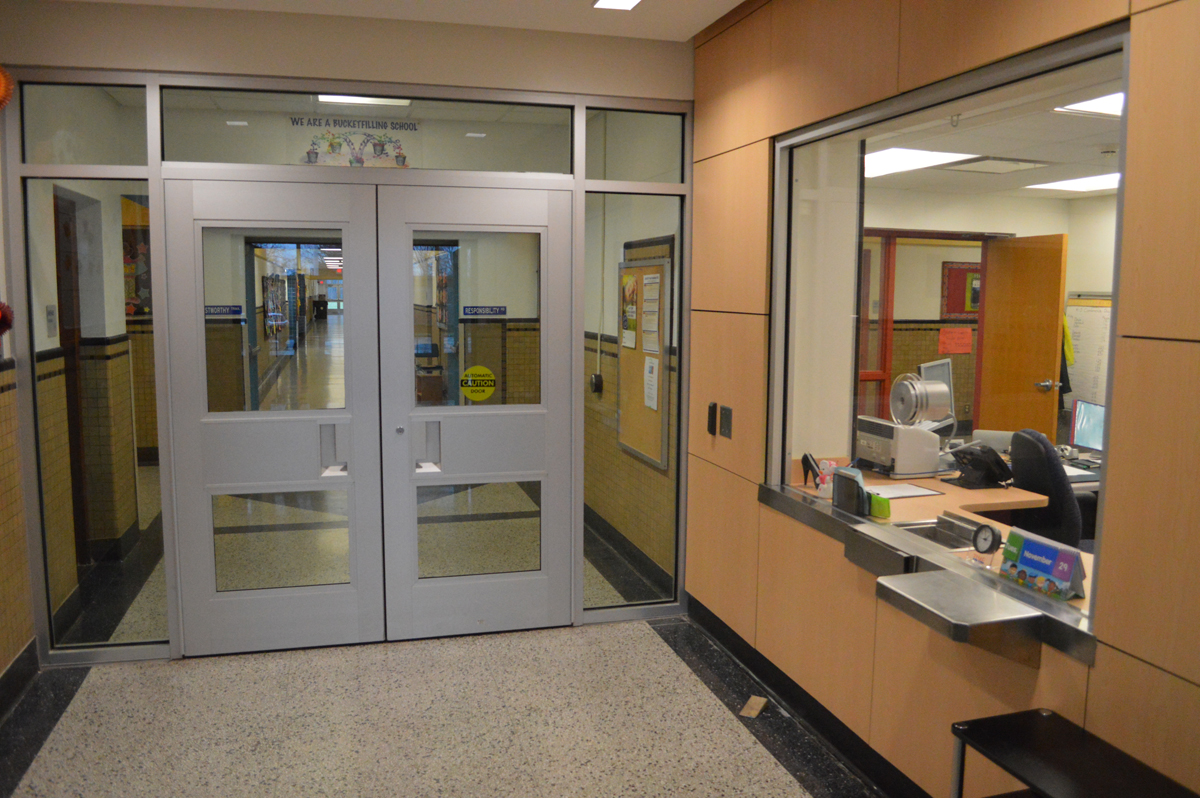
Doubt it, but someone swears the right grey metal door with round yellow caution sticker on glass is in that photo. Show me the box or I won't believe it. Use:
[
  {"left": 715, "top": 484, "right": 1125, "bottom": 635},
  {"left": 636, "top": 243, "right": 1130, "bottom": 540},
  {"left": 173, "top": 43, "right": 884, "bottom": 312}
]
[{"left": 379, "top": 186, "right": 574, "bottom": 640}]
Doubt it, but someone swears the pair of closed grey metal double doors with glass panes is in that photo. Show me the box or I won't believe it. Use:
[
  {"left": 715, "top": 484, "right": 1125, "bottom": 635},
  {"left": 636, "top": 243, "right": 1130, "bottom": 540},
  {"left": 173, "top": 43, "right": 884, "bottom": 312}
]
[{"left": 167, "top": 181, "right": 572, "bottom": 655}]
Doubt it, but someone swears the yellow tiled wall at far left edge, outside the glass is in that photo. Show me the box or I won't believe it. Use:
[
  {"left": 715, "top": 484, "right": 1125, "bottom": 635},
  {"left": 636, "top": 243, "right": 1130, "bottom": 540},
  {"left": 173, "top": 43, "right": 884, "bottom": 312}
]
[{"left": 0, "top": 368, "right": 34, "bottom": 673}]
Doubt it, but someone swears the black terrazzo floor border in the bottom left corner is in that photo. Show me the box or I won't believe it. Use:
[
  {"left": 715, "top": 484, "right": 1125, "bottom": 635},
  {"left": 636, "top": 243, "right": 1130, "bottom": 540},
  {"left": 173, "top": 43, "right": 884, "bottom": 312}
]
[{"left": 0, "top": 667, "right": 91, "bottom": 798}]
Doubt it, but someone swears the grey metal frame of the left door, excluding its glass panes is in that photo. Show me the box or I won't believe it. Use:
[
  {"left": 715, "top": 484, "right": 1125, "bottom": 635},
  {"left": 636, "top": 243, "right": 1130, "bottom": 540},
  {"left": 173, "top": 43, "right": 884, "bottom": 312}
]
[{"left": 164, "top": 180, "right": 383, "bottom": 656}]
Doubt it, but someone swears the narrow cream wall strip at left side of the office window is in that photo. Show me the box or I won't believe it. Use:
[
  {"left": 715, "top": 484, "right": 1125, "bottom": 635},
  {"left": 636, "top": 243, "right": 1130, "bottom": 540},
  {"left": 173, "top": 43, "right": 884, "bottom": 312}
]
[{"left": 791, "top": 137, "right": 858, "bottom": 458}]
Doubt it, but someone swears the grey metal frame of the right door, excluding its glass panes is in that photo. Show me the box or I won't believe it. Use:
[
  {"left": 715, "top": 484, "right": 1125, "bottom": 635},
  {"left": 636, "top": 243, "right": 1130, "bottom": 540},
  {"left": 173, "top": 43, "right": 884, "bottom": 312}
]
[{"left": 379, "top": 186, "right": 573, "bottom": 640}]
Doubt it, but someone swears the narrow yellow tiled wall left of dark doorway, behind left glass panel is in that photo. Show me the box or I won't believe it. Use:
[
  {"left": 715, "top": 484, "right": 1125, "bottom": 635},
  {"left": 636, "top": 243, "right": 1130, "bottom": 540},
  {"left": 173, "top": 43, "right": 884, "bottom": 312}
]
[{"left": 37, "top": 358, "right": 78, "bottom": 610}]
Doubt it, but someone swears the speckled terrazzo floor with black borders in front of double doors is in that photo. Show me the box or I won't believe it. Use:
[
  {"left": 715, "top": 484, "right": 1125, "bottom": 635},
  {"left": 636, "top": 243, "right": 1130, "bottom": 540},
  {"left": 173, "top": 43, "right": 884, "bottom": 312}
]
[{"left": 0, "top": 618, "right": 875, "bottom": 798}]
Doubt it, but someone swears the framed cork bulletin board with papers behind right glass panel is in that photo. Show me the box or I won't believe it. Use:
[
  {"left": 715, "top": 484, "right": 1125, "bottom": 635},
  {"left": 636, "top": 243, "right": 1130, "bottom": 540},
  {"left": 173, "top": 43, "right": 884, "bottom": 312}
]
[{"left": 617, "top": 236, "right": 674, "bottom": 468}]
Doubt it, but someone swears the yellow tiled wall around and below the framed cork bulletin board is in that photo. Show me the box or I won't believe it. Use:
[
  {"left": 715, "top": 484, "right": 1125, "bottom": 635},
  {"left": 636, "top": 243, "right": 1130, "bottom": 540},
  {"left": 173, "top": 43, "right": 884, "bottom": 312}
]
[{"left": 583, "top": 338, "right": 679, "bottom": 574}]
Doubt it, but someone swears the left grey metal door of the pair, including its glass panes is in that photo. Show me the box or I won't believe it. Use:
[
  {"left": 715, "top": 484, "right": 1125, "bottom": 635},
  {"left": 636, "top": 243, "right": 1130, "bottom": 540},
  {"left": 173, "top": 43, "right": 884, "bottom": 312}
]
[{"left": 167, "top": 180, "right": 384, "bottom": 656}]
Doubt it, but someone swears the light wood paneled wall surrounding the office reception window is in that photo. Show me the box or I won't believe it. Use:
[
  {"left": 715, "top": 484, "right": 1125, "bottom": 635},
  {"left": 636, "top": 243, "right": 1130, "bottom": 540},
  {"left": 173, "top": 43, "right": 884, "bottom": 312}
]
[{"left": 688, "top": 0, "right": 1200, "bottom": 794}]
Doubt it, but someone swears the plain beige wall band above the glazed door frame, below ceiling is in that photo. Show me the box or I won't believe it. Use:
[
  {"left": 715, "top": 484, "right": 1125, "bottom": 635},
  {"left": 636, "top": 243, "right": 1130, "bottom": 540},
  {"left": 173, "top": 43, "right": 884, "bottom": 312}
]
[{"left": 0, "top": 0, "right": 694, "bottom": 100}]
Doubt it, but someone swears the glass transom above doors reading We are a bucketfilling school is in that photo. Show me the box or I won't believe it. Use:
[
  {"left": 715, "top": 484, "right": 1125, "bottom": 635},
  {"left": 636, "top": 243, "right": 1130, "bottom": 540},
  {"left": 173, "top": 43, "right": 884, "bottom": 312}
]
[{"left": 162, "top": 89, "right": 571, "bottom": 174}]
